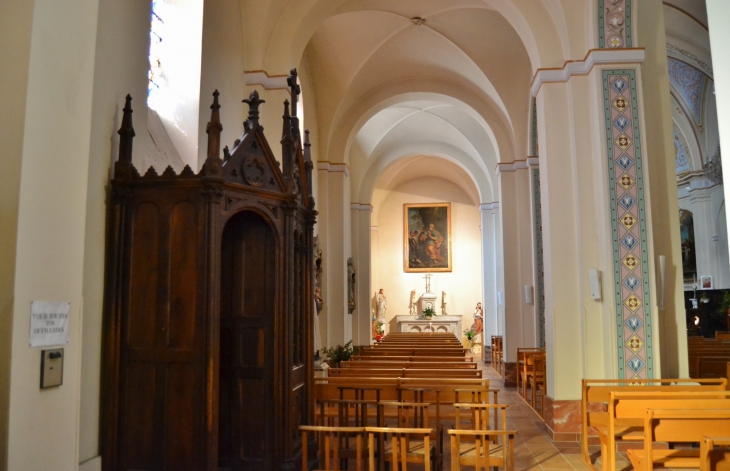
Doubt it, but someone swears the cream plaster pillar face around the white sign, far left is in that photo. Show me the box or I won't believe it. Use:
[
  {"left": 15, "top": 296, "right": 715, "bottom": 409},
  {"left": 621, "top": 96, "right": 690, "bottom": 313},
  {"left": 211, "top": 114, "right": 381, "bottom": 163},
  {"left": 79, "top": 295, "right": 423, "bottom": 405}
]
[{"left": 7, "top": 0, "right": 98, "bottom": 470}]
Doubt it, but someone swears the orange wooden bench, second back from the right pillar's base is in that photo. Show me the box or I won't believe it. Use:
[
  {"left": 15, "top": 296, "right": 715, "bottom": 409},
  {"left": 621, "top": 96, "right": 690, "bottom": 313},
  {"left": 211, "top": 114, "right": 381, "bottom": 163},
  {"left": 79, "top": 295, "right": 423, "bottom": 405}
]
[{"left": 598, "top": 388, "right": 730, "bottom": 471}]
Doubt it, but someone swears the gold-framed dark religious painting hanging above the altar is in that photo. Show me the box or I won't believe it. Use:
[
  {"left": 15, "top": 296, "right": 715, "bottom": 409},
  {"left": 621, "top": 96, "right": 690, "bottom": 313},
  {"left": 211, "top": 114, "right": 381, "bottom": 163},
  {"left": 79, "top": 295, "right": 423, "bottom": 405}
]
[{"left": 403, "top": 203, "right": 452, "bottom": 273}]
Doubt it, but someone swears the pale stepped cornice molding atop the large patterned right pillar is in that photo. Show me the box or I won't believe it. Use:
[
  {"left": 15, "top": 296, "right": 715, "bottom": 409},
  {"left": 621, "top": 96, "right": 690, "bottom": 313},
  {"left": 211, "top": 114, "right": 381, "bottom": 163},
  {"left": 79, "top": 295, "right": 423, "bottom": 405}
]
[{"left": 530, "top": 47, "right": 646, "bottom": 96}]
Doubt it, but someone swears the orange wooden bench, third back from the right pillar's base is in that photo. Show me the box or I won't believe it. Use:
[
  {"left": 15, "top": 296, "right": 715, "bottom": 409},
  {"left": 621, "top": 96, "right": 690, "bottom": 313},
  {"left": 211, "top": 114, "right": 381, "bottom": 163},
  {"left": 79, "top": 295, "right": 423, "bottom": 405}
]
[{"left": 628, "top": 408, "right": 730, "bottom": 471}]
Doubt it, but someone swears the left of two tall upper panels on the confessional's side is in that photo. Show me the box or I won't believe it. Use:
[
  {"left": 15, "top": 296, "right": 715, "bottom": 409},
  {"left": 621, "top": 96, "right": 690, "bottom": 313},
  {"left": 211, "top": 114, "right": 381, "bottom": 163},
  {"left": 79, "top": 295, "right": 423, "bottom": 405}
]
[{"left": 126, "top": 203, "right": 160, "bottom": 348}]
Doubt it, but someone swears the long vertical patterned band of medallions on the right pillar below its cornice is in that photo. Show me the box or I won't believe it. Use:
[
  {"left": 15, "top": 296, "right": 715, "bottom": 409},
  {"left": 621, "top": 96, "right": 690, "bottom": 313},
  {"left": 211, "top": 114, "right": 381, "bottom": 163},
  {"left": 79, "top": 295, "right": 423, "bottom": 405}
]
[{"left": 603, "top": 69, "right": 654, "bottom": 379}]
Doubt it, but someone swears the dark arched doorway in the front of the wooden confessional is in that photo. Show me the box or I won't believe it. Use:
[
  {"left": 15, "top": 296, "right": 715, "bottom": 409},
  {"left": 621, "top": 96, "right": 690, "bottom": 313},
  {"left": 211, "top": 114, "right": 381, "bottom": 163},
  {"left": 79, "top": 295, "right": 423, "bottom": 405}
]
[{"left": 218, "top": 211, "right": 277, "bottom": 471}]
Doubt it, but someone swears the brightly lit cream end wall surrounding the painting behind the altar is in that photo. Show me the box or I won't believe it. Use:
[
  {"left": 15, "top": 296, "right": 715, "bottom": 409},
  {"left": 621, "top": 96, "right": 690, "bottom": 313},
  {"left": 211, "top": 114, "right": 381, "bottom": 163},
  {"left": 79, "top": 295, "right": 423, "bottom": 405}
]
[{"left": 372, "top": 177, "right": 487, "bottom": 336}]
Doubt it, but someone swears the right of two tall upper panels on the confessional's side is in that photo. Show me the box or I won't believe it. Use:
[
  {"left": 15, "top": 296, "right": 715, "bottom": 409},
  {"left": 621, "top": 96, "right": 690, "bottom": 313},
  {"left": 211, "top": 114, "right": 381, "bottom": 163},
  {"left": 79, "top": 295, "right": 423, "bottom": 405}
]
[{"left": 168, "top": 201, "right": 199, "bottom": 348}]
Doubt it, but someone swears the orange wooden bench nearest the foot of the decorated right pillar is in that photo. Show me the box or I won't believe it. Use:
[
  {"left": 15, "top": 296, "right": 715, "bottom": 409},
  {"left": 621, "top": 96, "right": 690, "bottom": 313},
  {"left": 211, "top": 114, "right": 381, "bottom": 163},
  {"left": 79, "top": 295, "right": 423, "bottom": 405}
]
[{"left": 581, "top": 379, "right": 727, "bottom": 467}]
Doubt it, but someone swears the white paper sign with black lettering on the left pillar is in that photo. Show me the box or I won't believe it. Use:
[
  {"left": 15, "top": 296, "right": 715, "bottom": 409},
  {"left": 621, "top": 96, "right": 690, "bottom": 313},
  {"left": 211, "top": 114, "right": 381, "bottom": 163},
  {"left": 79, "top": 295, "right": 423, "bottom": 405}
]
[{"left": 30, "top": 301, "right": 71, "bottom": 347}]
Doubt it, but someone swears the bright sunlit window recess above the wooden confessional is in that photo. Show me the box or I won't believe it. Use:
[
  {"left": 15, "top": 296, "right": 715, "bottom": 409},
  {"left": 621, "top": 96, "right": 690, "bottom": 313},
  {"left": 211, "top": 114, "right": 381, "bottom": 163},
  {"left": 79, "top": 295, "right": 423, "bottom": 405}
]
[{"left": 147, "top": 0, "right": 203, "bottom": 168}]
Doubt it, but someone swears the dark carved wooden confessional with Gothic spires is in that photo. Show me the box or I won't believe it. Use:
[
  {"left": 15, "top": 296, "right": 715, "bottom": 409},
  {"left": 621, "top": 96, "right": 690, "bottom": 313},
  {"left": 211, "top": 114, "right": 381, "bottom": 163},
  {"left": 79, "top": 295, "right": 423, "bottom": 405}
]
[{"left": 101, "top": 70, "right": 316, "bottom": 471}]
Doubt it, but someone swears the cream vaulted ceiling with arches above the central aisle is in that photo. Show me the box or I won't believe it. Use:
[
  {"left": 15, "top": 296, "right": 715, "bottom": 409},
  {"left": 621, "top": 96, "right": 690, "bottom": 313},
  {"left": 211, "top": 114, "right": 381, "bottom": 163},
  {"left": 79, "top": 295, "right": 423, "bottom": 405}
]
[{"left": 242, "top": 0, "right": 588, "bottom": 203}]
